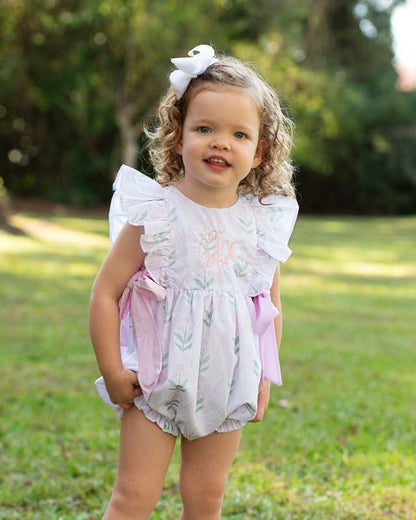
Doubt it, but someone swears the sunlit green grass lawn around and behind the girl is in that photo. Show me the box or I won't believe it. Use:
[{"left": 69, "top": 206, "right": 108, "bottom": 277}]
[{"left": 0, "top": 209, "right": 416, "bottom": 520}]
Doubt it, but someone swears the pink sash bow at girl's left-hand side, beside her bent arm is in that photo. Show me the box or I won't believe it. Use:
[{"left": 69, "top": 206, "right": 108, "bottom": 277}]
[{"left": 119, "top": 271, "right": 166, "bottom": 399}]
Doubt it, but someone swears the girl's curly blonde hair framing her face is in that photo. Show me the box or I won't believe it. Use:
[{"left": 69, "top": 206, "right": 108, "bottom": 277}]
[{"left": 145, "top": 56, "right": 295, "bottom": 200}]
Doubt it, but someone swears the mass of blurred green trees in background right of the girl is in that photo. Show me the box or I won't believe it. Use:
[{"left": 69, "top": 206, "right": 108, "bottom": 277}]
[{"left": 231, "top": 0, "right": 416, "bottom": 213}]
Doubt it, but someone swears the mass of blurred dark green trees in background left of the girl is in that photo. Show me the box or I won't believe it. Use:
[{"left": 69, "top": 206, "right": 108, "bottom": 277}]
[{"left": 0, "top": 0, "right": 232, "bottom": 204}]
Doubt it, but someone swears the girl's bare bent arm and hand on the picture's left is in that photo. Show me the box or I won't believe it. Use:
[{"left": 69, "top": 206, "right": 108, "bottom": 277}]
[{"left": 89, "top": 224, "right": 145, "bottom": 408}]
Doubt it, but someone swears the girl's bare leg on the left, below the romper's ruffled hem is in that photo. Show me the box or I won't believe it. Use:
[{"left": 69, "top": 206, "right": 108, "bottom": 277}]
[{"left": 103, "top": 407, "right": 176, "bottom": 520}]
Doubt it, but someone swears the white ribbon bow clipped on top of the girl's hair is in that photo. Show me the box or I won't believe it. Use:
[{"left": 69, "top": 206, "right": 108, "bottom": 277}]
[{"left": 169, "top": 45, "right": 217, "bottom": 99}]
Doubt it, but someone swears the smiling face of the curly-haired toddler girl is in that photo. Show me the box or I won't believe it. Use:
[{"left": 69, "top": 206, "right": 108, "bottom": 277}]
[{"left": 177, "top": 85, "right": 262, "bottom": 198}]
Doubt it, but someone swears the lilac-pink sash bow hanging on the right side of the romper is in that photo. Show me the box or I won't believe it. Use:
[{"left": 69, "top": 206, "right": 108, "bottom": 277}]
[{"left": 253, "top": 291, "right": 282, "bottom": 386}]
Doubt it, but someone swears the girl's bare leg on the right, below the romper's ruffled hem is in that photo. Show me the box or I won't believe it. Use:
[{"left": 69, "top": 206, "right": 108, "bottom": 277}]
[{"left": 180, "top": 430, "right": 241, "bottom": 520}]
